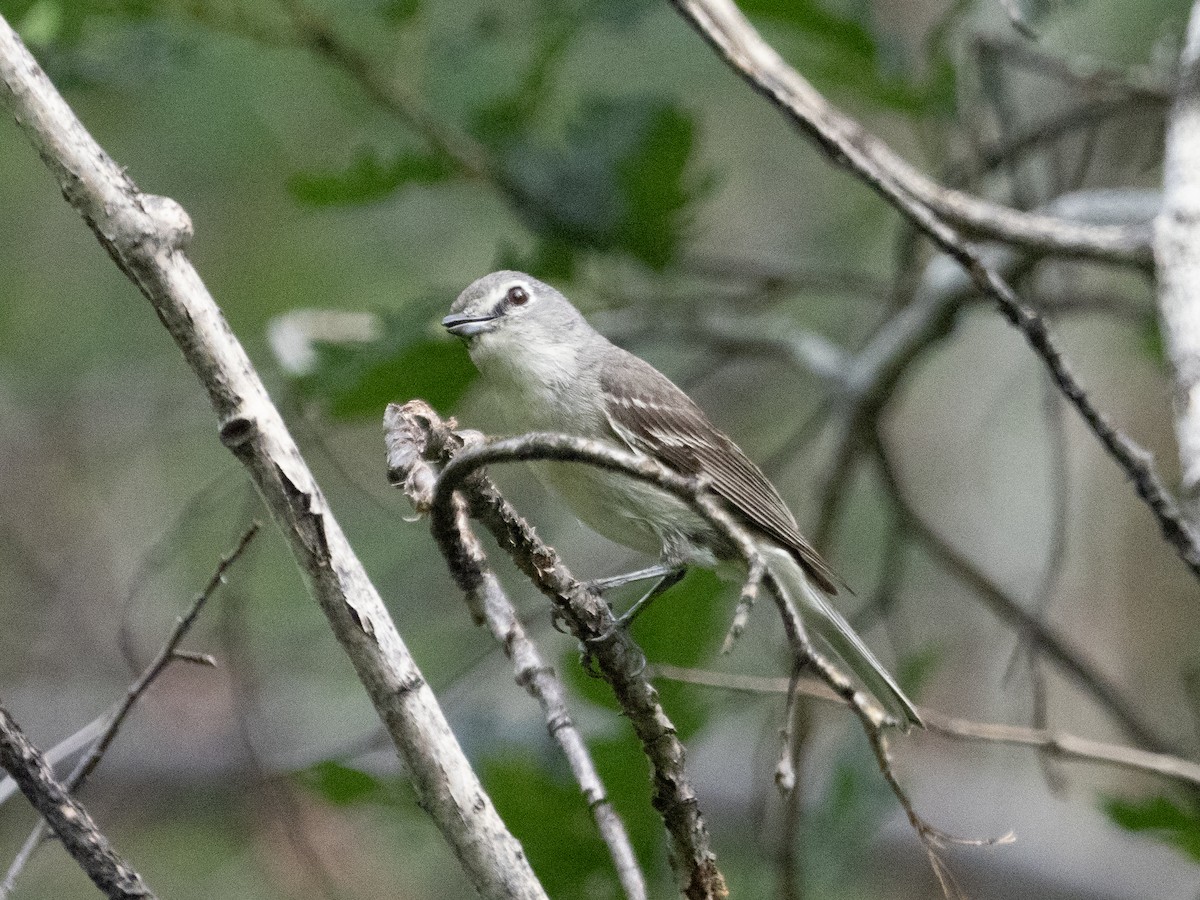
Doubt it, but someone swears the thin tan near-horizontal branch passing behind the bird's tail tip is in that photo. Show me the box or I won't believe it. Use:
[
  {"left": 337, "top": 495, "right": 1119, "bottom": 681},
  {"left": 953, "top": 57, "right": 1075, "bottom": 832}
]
[{"left": 649, "top": 664, "right": 1200, "bottom": 787}]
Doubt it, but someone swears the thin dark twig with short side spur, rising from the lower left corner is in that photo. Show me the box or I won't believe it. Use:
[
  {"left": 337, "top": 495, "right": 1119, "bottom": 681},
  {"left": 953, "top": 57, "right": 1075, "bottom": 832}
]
[{"left": 0, "top": 522, "right": 260, "bottom": 900}]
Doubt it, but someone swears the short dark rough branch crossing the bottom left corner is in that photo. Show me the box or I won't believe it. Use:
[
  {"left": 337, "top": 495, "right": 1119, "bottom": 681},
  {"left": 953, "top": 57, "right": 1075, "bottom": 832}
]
[{"left": 0, "top": 708, "right": 155, "bottom": 900}]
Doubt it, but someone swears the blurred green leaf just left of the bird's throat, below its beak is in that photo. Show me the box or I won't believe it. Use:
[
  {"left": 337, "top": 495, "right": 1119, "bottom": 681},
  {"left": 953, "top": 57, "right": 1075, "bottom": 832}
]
[{"left": 286, "top": 298, "right": 475, "bottom": 419}]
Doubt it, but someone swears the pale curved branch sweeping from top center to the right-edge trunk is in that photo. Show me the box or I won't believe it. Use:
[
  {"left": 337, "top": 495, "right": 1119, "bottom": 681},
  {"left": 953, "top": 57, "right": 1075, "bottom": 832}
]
[{"left": 672, "top": 0, "right": 1151, "bottom": 265}]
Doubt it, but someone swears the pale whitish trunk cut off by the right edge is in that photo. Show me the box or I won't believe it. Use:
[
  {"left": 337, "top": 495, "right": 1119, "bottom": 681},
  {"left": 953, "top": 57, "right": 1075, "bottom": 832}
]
[{"left": 1154, "top": 4, "right": 1200, "bottom": 528}]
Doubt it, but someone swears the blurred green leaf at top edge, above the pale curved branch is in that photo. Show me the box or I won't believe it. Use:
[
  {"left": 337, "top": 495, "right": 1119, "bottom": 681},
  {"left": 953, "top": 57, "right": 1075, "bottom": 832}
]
[{"left": 738, "top": 0, "right": 955, "bottom": 115}]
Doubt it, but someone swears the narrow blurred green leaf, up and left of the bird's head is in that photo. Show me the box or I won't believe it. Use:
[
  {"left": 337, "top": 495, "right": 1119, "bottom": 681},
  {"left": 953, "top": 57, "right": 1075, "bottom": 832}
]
[{"left": 288, "top": 150, "right": 457, "bottom": 206}]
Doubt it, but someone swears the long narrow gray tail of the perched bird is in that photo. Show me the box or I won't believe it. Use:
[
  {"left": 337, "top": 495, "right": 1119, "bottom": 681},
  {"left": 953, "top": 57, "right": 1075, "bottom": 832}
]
[{"left": 760, "top": 545, "right": 922, "bottom": 730}]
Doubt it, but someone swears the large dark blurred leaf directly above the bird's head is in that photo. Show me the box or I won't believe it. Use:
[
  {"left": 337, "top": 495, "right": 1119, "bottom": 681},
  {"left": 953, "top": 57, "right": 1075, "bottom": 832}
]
[{"left": 500, "top": 98, "right": 701, "bottom": 269}]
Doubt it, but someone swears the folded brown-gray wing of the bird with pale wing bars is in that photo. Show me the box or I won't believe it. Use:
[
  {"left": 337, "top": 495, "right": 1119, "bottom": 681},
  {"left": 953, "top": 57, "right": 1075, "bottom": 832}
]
[{"left": 600, "top": 350, "right": 838, "bottom": 594}]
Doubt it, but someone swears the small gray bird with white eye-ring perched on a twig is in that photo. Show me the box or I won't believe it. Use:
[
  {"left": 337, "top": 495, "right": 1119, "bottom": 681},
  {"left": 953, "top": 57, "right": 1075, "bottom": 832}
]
[{"left": 442, "top": 271, "right": 922, "bottom": 727}]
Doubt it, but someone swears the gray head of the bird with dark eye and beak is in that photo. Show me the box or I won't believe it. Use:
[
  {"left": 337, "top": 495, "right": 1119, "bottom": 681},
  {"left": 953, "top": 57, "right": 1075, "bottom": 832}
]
[{"left": 442, "top": 271, "right": 592, "bottom": 374}]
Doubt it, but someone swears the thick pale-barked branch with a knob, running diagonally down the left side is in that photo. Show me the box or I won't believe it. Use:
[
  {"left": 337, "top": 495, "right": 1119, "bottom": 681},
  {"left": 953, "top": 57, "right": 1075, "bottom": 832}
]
[{"left": 0, "top": 18, "right": 545, "bottom": 900}]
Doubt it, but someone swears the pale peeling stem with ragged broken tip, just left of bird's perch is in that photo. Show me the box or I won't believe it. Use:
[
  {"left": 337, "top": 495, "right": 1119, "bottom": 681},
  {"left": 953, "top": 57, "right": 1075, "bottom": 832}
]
[{"left": 384, "top": 403, "right": 646, "bottom": 900}]
